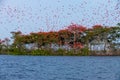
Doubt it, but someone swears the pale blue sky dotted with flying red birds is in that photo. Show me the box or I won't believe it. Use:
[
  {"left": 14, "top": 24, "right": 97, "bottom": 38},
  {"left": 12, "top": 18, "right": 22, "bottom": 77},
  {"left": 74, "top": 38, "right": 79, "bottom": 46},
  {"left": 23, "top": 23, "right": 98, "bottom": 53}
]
[{"left": 0, "top": 0, "right": 120, "bottom": 39}]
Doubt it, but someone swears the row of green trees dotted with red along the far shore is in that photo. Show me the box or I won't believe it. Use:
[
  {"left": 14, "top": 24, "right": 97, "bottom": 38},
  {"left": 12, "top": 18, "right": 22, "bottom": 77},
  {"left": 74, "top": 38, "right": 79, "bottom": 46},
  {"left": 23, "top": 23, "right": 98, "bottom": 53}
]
[{"left": 0, "top": 24, "right": 120, "bottom": 56}]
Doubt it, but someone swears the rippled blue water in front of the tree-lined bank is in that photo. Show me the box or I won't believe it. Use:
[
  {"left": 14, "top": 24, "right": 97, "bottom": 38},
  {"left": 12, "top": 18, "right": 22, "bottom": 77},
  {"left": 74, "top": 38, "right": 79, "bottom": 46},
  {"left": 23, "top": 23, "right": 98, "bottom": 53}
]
[{"left": 0, "top": 55, "right": 120, "bottom": 80}]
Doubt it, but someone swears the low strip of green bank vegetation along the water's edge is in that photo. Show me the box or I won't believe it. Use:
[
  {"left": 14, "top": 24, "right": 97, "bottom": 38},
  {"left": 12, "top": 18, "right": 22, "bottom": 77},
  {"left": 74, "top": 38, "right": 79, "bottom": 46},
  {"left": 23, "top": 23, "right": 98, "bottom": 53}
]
[{"left": 0, "top": 48, "right": 120, "bottom": 56}]
